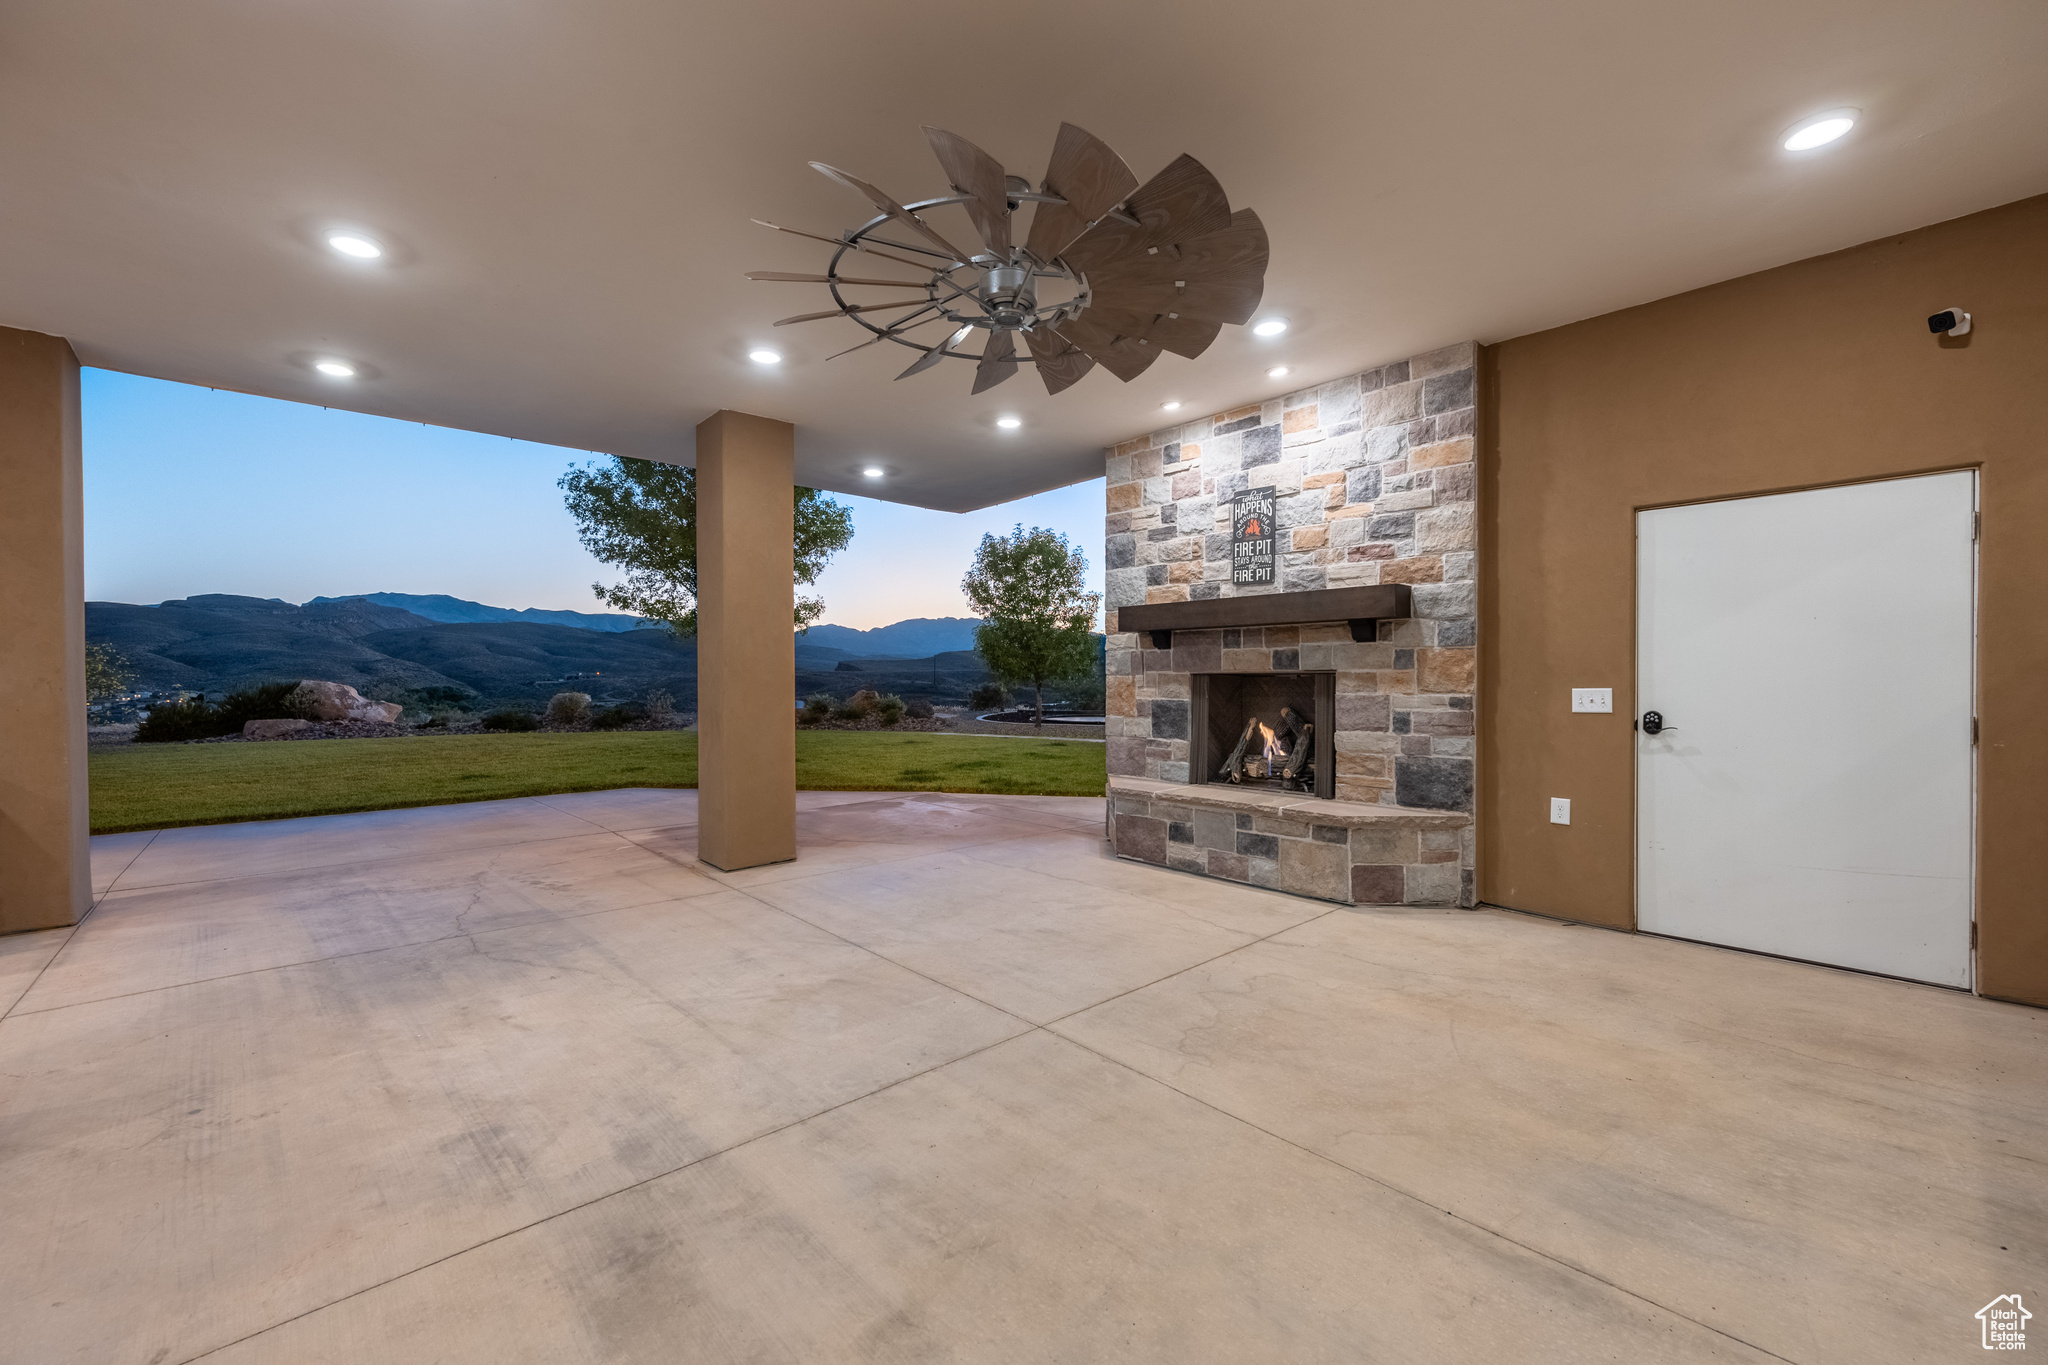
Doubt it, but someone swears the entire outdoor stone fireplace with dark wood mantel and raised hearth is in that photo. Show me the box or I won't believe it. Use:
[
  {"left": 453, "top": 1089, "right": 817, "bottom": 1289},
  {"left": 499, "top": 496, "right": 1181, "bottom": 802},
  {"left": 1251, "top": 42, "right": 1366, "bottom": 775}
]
[{"left": 1106, "top": 344, "right": 1477, "bottom": 905}]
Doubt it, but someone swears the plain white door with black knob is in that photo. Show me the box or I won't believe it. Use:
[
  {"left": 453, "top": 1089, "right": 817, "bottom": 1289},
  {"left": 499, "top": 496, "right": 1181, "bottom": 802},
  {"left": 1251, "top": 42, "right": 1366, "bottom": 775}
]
[{"left": 1634, "top": 473, "right": 1976, "bottom": 986}]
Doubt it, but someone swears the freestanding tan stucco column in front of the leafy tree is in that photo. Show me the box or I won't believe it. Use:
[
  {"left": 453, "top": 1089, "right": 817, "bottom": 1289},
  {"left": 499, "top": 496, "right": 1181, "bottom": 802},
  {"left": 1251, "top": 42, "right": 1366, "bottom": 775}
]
[{"left": 696, "top": 411, "right": 797, "bottom": 872}]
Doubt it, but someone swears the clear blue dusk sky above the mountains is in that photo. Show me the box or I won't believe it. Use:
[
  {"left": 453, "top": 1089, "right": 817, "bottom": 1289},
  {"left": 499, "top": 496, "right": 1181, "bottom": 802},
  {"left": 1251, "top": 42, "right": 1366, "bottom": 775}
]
[{"left": 84, "top": 370, "right": 1102, "bottom": 628}]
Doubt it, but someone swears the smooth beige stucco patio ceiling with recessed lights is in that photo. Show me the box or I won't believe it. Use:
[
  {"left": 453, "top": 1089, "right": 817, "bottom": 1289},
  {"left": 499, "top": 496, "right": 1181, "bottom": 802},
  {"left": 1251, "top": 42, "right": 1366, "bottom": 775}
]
[{"left": 0, "top": 0, "right": 2048, "bottom": 510}]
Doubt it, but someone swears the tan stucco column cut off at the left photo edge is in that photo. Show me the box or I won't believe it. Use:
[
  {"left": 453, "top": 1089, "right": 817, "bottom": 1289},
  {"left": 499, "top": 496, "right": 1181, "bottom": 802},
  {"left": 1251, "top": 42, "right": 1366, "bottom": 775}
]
[{"left": 0, "top": 327, "right": 88, "bottom": 933}]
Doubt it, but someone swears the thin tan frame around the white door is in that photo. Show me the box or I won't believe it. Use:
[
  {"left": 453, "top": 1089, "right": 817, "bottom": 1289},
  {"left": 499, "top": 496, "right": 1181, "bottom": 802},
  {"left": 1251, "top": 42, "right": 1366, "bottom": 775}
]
[{"left": 1628, "top": 460, "right": 1985, "bottom": 997}]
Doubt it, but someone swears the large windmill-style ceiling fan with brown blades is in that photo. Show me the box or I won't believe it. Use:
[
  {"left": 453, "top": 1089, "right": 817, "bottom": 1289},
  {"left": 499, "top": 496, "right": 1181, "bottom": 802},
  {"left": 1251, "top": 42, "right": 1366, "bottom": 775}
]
[{"left": 748, "top": 123, "right": 1268, "bottom": 393}]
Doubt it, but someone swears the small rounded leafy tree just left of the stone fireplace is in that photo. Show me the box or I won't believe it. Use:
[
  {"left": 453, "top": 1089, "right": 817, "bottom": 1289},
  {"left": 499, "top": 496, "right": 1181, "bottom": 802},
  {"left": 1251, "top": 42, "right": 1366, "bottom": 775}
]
[{"left": 961, "top": 526, "right": 1102, "bottom": 724}]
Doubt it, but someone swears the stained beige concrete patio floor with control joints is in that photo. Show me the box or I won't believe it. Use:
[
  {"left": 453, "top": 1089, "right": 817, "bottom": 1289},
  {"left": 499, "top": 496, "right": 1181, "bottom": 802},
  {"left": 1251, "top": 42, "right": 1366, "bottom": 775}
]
[{"left": 0, "top": 790, "right": 2048, "bottom": 1365}]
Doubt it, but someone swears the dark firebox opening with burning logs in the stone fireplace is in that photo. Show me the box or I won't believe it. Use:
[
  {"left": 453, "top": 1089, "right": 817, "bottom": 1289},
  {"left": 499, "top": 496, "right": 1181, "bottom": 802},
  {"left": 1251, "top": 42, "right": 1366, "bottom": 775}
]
[{"left": 1188, "top": 673, "right": 1337, "bottom": 800}]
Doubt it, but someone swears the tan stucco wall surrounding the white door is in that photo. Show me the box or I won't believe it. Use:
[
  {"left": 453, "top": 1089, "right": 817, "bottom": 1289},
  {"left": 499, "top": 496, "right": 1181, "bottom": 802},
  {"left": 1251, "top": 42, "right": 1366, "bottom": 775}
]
[{"left": 1479, "top": 196, "right": 2048, "bottom": 1005}]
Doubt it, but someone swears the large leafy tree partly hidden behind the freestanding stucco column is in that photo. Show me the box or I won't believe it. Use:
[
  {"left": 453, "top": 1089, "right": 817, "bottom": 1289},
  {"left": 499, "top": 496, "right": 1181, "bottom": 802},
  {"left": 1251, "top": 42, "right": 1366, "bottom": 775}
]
[{"left": 559, "top": 454, "right": 854, "bottom": 636}]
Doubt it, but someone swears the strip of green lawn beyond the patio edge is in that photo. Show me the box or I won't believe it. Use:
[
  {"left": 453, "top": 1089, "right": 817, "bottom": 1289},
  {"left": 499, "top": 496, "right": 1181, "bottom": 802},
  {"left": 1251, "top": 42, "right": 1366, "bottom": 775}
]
[{"left": 92, "top": 731, "right": 1104, "bottom": 835}]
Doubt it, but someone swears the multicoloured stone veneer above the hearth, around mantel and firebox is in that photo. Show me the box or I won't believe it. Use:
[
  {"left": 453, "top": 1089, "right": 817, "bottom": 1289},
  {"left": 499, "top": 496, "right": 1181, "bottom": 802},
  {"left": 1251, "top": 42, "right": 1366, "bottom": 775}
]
[{"left": 1104, "top": 342, "right": 1479, "bottom": 902}]
